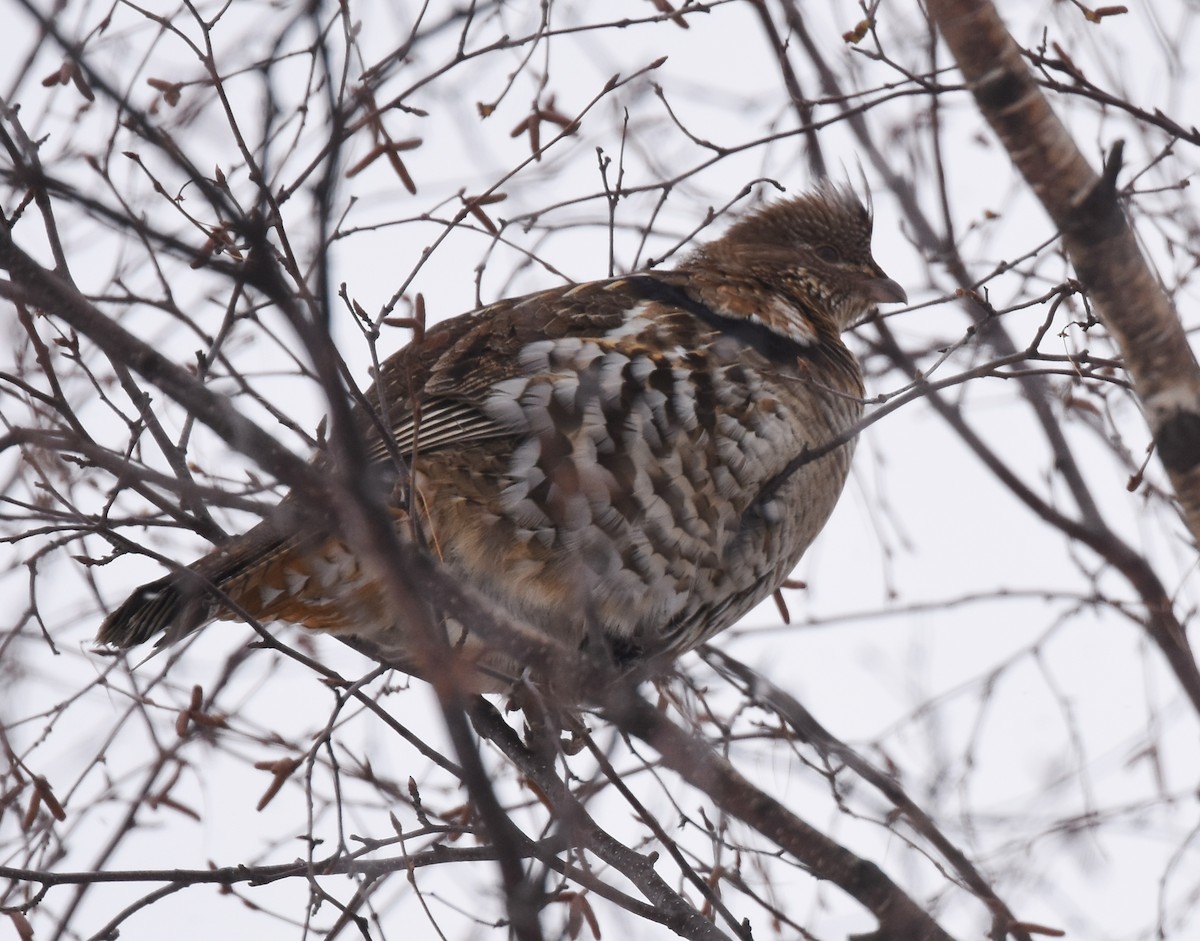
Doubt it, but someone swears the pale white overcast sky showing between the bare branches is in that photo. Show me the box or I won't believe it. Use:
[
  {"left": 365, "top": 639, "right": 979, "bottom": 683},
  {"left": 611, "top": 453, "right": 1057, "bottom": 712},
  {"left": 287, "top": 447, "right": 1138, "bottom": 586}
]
[{"left": 0, "top": 0, "right": 1200, "bottom": 941}]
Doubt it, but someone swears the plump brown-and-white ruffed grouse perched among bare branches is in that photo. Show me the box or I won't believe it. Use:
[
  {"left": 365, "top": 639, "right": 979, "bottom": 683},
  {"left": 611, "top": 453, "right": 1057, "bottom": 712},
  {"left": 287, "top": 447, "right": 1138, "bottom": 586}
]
[{"left": 98, "top": 182, "right": 906, "bottom": 689}]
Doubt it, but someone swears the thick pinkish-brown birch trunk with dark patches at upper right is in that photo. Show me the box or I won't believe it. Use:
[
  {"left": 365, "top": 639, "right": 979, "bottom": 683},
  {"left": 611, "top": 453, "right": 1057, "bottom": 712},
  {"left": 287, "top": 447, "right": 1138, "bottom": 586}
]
[{"left": 929, "top": 0, "right": 1200, "bottom": 545}]
